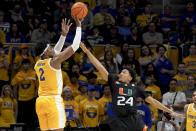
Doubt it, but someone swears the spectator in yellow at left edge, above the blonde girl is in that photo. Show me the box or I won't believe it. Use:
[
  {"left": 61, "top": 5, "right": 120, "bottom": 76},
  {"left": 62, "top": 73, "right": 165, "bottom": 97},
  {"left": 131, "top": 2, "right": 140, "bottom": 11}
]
[{"left": 0, "top": 43, "right": 10, "bottom": 93}]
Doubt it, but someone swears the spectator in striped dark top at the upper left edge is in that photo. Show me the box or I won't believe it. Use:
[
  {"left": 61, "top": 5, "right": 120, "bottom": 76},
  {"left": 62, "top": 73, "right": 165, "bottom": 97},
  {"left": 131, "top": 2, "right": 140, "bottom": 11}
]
[{"left": 0, "top": 10, "right": 10, "bottom": 33}]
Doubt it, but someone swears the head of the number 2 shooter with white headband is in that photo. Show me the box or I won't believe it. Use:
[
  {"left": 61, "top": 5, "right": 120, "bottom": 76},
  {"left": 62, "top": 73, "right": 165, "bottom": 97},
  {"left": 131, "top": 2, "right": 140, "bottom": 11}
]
[{"left": 35, "top": 42, "right": 55, "bottom": 59}]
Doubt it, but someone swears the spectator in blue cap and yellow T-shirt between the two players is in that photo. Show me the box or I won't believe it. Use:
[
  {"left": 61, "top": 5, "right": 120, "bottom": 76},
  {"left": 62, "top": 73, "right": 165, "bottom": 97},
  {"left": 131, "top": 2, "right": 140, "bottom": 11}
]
[{"left": 79, "top": 85, "right": 104, "bottom": 127}]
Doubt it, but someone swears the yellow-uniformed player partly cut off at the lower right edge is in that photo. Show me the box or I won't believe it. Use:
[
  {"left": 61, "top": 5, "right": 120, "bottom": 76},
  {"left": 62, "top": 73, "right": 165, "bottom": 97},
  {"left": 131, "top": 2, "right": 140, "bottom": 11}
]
[{"left": 179, "top": 91, "right": 196, "bottom": 131}]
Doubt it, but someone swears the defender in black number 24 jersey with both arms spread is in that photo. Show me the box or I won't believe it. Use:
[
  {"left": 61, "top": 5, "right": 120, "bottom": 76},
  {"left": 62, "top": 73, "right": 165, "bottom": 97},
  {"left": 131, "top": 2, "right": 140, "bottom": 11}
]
[{"left": 80, "top": 42, "right": 183, "bottom": 131}]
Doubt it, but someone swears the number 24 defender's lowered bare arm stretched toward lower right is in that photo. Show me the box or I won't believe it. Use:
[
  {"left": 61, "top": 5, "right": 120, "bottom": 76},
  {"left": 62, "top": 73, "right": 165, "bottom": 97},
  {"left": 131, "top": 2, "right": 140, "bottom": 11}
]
[{"left": 145, "top": 96, "right": 184, "bottom": 118}]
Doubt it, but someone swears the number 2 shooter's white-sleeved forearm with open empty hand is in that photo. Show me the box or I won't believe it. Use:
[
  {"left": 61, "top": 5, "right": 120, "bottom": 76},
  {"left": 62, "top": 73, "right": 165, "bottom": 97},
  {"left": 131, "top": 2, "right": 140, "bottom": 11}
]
[{"left": 54, "top": 18, "right": 72, "bottom": 54}]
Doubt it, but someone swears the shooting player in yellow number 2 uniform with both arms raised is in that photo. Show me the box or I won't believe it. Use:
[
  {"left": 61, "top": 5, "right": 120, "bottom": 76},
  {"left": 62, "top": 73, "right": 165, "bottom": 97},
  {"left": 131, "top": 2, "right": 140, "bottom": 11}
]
[{"left": 35, "top": 18, "right": 81, "bottom": 131}]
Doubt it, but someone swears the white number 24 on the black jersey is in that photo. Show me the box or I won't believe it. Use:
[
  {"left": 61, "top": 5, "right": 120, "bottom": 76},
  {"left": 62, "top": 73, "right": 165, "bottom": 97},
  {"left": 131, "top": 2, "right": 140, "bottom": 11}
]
[{"left": 117, "top": 96, "right": 133, "bottom": 106}]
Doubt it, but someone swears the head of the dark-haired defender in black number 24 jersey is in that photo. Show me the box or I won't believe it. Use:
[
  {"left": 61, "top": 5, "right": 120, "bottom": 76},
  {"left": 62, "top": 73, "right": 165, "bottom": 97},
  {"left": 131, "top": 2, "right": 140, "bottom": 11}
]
[{"left": 119, "top": 67, "right": 135, "bottom": 83}]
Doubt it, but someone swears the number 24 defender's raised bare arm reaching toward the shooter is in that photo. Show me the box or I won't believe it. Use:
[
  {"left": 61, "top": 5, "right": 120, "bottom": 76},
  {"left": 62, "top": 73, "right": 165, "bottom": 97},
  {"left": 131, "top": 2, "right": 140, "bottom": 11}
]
[{"left": 80, "top": 42, "right": 108, "bottom": 81}]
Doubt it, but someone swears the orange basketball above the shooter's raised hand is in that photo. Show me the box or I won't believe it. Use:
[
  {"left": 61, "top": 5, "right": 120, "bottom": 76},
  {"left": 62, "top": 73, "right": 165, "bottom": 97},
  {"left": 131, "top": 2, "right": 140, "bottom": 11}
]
[{"left": 71, "top": 2, "right": 88, "bottom": 19}]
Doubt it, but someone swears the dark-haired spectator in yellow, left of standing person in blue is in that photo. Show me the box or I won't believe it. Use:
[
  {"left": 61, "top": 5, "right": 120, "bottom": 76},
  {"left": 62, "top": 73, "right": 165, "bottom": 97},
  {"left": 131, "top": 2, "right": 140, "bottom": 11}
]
[{"left": 138, "top": 45, "right": 154, "bottom": 70}]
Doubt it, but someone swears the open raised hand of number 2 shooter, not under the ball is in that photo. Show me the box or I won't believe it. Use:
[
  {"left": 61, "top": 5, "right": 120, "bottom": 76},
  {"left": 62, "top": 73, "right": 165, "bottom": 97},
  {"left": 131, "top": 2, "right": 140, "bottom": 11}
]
[{"left": 61, "top": 18, "right": 72, "bottom": 36}]
